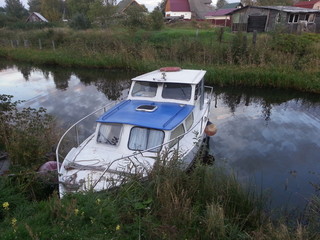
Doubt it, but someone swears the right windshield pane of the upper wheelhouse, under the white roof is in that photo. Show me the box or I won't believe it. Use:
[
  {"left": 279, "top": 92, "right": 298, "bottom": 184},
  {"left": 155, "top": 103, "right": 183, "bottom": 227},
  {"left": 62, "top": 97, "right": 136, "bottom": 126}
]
[{"left": 162, "top": 83, "right": 191, "bottom": 100}]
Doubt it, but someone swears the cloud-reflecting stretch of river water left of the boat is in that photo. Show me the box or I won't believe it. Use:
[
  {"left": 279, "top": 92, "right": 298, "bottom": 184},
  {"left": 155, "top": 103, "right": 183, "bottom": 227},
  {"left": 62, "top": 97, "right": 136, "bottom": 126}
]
[{"left": 0, "top": 62, "right": 131, "bottom": 126}]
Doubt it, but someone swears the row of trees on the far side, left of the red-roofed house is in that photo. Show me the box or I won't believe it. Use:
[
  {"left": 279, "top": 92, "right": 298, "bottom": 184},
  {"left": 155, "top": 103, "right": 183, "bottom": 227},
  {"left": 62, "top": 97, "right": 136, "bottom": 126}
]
[{"left": 0, "top": 0, "right": 164, "bottom": 29}]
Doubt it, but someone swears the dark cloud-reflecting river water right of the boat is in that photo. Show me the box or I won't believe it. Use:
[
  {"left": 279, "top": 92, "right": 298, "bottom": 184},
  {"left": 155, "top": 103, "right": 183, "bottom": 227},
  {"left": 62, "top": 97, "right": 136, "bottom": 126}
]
[{"left": 210, "top": 89, "right": 320, "bottom": 209}]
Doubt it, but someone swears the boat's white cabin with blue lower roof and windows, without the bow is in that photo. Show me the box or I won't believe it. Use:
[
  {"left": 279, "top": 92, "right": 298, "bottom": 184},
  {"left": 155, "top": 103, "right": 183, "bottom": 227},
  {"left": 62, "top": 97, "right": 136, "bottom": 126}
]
[{"left": 96, "top": 69, "right": 205, "bottom": 153}]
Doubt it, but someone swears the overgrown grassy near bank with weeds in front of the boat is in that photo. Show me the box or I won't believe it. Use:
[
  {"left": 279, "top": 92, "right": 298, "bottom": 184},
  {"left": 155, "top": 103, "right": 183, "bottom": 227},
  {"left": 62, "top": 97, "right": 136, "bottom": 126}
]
[{"left": 0, "top": 161, "right": 320, "bottom": 240}]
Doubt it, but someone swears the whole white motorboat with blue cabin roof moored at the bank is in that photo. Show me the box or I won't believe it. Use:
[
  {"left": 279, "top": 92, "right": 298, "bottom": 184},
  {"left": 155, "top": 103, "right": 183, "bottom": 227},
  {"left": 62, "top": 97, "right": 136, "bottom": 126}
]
[{"left": 56, "top": 67, "right": 213, "bottom": 197}]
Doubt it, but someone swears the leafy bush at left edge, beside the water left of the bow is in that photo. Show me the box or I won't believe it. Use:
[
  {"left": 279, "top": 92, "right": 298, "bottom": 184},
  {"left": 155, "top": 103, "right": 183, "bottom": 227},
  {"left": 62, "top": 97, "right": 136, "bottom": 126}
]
[{"left": 0, "top": 95, "right": 58, "bottom": 170}]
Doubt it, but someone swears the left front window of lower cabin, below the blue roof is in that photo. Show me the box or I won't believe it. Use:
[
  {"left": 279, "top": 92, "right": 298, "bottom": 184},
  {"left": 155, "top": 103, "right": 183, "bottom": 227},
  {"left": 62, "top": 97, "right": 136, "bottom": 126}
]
[{"left": 97, "top": 123, "right": 122, "bottom": 146}]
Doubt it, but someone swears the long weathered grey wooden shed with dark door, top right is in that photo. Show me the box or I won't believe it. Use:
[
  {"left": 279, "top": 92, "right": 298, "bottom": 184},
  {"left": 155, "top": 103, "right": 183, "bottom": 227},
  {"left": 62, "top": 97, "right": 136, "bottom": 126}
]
[{"left": 230, "top": 6, "right": 320, "bottom": 33}]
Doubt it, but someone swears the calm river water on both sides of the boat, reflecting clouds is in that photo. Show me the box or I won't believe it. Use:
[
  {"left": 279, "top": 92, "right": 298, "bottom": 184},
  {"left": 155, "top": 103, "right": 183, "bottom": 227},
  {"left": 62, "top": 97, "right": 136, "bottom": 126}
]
[{"left": 0, "top": 60, "right": 320, "bottom": 213}]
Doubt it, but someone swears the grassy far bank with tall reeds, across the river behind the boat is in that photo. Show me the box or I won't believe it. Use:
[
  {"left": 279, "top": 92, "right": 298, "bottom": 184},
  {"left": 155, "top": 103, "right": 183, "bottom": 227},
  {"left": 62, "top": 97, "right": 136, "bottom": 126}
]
[{"left": 0, "top": 28, "right": 320, "bottom": 93}]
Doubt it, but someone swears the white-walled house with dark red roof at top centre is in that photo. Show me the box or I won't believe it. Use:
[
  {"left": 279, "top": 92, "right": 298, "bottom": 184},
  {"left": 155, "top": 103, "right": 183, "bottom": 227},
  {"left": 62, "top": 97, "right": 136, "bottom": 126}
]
[{"left": 165, "top": 0, "right": 191, "bottom": 19}]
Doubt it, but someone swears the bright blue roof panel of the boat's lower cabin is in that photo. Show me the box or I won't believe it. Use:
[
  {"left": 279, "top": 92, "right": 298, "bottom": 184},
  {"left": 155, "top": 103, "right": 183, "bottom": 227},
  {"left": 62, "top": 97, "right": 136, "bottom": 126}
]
[{"left": 97, "top": 100, "right": 194, "bottom": 130}]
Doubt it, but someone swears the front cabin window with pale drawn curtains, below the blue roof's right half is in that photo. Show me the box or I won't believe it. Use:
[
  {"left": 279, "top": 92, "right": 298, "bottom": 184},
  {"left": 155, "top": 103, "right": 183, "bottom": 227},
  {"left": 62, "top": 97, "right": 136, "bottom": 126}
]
[{"left": 128, "top": 127, "right": 164, "bottom": 152}]
